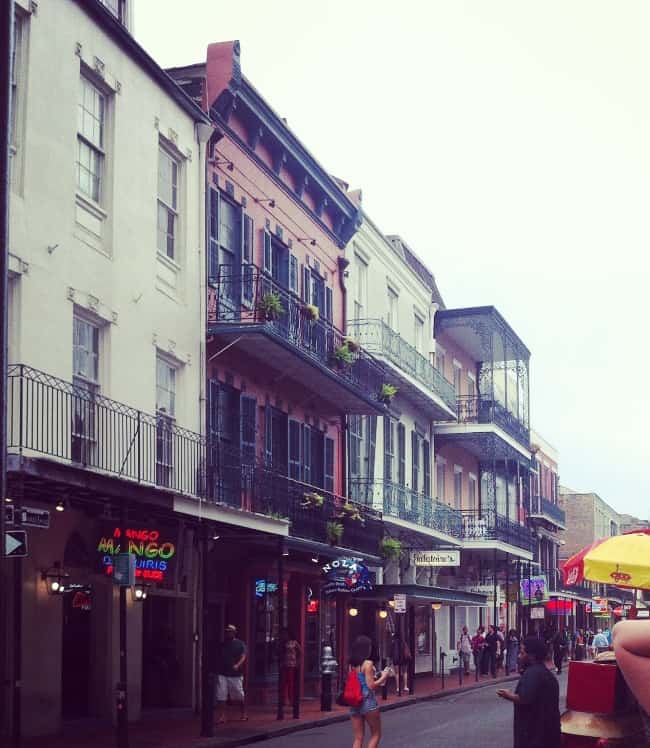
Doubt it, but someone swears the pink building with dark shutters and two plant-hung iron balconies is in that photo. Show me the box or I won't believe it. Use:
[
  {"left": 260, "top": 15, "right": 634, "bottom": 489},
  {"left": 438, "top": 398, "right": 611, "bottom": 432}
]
[{"left": 170, "top": 42, "right": 386, "bottom": 699}]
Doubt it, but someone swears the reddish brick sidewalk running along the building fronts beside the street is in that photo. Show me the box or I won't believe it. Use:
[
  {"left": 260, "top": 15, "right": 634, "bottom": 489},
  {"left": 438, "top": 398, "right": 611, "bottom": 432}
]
[{"left": 22, "top": 674, "right": 517, "bottom": 748}]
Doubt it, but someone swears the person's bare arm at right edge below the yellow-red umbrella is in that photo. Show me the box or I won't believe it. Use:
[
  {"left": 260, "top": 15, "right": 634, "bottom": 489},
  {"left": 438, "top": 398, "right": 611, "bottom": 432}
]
[{"left": 613, "top": 621, "right": 650, "bottom": 714}]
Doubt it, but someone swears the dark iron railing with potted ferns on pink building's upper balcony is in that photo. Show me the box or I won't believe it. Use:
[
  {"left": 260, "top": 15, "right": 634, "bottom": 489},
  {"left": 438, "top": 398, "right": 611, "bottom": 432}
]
[{"left": 208, "top": 265, "right": 385, "bottom": 400}]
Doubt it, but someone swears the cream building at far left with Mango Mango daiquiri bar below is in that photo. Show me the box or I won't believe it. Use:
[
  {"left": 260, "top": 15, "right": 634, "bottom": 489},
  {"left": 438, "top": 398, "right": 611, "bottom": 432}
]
[{"left": 8, "top": 0, "right": 211, "bottom": 734}]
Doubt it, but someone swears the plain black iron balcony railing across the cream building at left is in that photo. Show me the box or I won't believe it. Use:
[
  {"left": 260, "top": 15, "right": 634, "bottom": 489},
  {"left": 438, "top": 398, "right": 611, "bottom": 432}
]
[{"left": 7, "top": 364, "right": 206, "bottom": 498}]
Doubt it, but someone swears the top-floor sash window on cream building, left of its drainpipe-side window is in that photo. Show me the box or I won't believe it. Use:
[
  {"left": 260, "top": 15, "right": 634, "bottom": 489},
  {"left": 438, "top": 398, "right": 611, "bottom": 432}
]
[{"left": 77, "top": 75, "right": 106, "bottom": 203}]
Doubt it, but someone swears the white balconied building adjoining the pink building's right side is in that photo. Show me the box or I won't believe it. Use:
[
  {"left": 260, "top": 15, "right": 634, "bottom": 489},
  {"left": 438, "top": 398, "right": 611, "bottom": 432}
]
[{"left": 346, "top": 202, "right": 485, "bottom": 672}]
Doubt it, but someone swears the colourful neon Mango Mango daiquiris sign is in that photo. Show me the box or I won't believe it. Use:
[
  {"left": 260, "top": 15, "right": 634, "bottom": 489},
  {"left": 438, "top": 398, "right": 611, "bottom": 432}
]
[{"left": 97, "top": 527, "right": 176, "bottom": 582}]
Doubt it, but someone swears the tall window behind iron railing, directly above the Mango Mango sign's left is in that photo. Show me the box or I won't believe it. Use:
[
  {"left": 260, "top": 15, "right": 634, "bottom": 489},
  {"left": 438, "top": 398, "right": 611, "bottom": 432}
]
[{"left": 70, "top": 316, "right": 99, "bottom": 465}]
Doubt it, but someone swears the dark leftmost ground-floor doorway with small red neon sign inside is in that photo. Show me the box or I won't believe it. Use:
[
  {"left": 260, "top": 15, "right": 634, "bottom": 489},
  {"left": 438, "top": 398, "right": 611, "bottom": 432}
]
[{"left": 61, "top": 587, "right": 92, "bottom": 720}]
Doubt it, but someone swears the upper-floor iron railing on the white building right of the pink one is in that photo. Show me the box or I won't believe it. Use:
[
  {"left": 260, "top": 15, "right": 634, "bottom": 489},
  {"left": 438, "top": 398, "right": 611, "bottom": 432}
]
[{"left": 348, "top": 319, "right": 456, "bottom": 410}]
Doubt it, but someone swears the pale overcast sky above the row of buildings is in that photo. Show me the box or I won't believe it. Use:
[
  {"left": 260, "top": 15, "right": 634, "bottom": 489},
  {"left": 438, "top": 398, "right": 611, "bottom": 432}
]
[{"left": 135, "top": 0, "right": 650, "bottom": 518}]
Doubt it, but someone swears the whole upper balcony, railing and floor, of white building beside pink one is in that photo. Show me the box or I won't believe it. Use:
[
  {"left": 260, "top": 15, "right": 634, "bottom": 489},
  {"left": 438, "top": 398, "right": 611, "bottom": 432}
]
[{"left": 348, "top": 319, "right": 456, "bottom": 421}]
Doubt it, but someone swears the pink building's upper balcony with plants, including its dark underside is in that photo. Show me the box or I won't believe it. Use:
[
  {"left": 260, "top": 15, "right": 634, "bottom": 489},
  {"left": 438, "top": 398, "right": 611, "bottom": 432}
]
[{"left": 208, "top": 265, "right": 388, "bottom": 414}]
